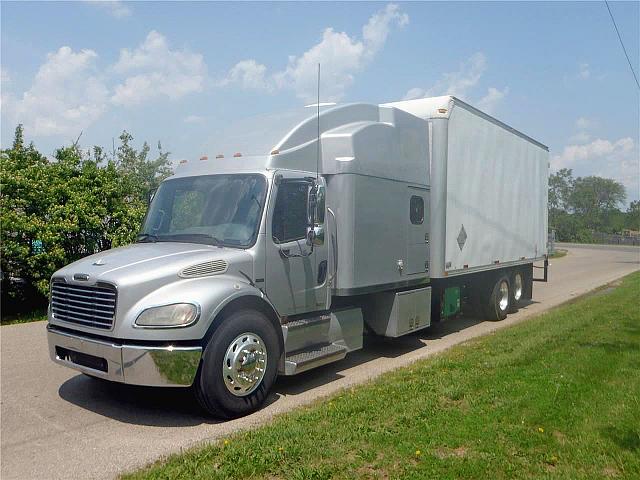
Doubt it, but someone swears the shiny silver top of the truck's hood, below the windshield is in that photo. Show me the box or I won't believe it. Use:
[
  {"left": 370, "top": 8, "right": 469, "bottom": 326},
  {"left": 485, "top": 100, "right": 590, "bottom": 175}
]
[{"left": 54, "top": 242, "right": 253, "bottom": 286}]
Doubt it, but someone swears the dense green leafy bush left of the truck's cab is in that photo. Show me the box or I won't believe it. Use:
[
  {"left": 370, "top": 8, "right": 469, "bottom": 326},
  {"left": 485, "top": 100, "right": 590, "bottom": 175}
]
[{"left": 0, "top": 125, "right": 171, "bottom": 297}]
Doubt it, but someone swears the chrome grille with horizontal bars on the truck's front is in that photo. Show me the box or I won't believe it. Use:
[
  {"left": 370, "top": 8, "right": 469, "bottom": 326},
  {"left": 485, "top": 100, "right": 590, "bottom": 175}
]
[{"left": 51, "top": 280, "right": 117, "bottom": 330}]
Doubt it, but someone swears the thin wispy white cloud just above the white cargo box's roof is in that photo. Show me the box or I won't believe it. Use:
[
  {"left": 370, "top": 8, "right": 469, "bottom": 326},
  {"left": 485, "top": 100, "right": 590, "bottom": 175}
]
[{"left": 403, "top": 52, "right": 509, "bottom": 114}]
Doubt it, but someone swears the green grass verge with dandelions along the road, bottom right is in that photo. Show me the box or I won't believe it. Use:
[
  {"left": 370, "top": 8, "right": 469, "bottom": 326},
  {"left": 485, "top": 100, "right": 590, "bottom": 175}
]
[{"left": 124, "top": 273, "right": 640, "bottom": 480}]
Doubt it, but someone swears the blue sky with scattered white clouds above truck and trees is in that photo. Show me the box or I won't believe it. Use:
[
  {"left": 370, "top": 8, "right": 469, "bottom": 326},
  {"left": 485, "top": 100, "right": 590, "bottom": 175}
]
[{"left": 1, "top": 2, "right": 640, "bottom": 200}]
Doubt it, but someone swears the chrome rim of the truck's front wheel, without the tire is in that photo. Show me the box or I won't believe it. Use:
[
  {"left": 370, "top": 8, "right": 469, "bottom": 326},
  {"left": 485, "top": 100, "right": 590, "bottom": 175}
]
[{"left": 222, "top": 332, "right": 267, "bottom": 397}]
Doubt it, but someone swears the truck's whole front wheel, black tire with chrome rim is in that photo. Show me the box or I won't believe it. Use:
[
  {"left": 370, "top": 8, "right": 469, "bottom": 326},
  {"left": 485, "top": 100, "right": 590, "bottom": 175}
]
[{"left": 194, "top": 310, "right": 280, "bottom": 419}]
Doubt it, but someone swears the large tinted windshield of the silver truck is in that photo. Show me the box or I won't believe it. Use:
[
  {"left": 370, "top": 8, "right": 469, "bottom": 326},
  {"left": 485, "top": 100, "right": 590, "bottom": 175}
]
[{"left": 138, "top": 174, "right": 267, "bottom": 247}]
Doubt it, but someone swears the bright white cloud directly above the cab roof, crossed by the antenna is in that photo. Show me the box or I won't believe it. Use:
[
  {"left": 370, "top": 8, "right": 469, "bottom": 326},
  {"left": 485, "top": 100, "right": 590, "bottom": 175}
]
[{"left": 219, "top": 4, "right": 409, "bottom": 101}]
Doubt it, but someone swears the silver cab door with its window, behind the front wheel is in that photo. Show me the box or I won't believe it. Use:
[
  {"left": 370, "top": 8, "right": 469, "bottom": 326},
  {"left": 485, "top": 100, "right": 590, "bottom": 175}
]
[{"left": 265, "top": 171, "right": 328, "bottom": 315}]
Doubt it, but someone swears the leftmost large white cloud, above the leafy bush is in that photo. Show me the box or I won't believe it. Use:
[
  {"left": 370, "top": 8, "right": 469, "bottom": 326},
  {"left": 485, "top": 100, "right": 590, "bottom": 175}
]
[{"left": 2, "top": 47, "right": 108, "bottom": 136}]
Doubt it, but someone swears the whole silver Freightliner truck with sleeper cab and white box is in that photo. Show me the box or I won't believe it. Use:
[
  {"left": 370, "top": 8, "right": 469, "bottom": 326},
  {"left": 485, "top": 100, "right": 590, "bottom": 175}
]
[{"left": 47, "top": 96, "right": 548, "bottom": 418}]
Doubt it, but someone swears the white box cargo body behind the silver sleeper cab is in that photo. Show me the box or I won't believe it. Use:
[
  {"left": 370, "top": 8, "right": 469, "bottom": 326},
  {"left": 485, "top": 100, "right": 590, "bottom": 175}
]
[{"left": 387, "top": 96, "right": 549, "bottom": 278}]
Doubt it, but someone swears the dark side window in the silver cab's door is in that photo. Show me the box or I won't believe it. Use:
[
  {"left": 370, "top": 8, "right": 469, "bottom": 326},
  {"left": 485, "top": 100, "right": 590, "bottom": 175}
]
[{"left": 271, "top": 182, "right": 309, "bottom": 243}]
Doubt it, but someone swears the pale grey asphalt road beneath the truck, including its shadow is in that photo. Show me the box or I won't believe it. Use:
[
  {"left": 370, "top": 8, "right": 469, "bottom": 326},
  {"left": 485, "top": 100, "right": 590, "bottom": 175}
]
[{"left": 0, "top": 246, "right": 640, "bottom": 480}]
